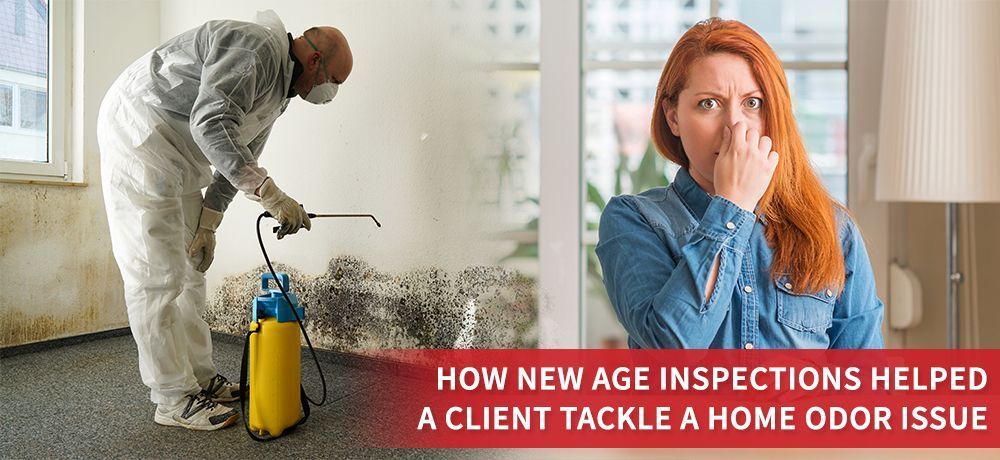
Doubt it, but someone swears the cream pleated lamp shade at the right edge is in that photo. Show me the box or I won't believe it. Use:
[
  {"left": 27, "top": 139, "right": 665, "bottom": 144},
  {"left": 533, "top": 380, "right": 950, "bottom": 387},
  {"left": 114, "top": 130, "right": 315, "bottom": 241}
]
[{"left": 875, "top": 0, "right": 1000, "bottom": 203}]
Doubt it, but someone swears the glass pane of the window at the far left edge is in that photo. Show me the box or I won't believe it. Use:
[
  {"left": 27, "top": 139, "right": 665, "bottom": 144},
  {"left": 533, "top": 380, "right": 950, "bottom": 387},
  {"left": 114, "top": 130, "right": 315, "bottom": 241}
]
[{"left": 0, "top": 0, "right": 49, "bottom": 163}]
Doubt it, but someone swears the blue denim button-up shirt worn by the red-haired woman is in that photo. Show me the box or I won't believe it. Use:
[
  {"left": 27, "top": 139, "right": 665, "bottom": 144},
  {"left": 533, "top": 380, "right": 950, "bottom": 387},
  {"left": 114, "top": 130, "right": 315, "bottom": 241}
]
[{"left": 597, "top": 169, "right": 883, "bottom": 349}]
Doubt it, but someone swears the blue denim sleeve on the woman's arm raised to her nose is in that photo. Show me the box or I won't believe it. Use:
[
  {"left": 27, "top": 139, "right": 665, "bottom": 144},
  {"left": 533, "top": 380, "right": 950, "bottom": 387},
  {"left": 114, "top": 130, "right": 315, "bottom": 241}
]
[{"left": 597, "top": 196, "right": 754, "bottom": 348}]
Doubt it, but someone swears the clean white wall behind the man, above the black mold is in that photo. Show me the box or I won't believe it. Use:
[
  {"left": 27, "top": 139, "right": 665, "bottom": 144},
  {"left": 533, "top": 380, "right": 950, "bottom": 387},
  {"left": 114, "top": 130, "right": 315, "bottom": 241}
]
[{"left": 160, "top": 0, "right": 509, "bottom": 301}]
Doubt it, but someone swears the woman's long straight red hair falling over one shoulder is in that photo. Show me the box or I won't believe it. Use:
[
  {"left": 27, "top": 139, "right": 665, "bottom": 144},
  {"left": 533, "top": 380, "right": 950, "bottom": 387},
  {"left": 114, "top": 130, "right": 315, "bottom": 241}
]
[{"left": 651, "top": 18, "right": 849, "bottom": 292}]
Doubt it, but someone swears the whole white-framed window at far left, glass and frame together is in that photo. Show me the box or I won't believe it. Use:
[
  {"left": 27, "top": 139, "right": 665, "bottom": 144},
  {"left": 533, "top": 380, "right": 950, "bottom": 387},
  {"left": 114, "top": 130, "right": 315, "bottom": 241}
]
[{"left": 0, "top": 0, "right": 72, "bottom": 181}]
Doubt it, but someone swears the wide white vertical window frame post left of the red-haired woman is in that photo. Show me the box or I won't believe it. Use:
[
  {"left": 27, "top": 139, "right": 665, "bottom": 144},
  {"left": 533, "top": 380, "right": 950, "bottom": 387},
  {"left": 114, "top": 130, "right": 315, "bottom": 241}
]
[{"left": 538, "top": 1, "right": 586, "bottom": 348}]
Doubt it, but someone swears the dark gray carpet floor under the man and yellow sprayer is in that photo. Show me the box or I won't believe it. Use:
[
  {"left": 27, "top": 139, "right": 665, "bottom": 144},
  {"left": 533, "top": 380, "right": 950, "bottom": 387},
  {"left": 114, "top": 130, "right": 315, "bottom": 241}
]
[{"left": 0, "top": 335, "right": 500, "bottom": 458}]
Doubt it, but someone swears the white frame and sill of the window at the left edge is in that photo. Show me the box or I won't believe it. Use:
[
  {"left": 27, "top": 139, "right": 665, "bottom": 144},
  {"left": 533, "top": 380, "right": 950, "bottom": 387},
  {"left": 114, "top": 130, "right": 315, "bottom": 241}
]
[{"left": 0, "top": 0, "right": 73, "bottom": 183}]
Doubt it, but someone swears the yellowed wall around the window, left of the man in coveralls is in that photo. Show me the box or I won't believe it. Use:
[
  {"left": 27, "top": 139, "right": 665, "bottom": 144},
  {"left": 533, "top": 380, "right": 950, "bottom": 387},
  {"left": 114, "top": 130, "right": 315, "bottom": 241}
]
[{"left": 0, "top": 0, "right": 159, "bottom": 346}]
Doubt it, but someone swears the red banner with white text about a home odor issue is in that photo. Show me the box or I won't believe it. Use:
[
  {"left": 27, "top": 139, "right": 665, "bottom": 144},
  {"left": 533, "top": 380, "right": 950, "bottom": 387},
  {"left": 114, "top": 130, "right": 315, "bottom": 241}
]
[{"left": 348, "top": 350, "right": 1000, "bottom": 448}]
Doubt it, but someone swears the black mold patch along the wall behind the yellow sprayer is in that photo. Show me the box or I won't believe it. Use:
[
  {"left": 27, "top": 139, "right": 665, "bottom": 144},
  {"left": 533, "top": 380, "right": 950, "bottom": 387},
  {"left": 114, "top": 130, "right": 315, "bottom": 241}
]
[{"left": 205, "top": 256, "right": 538, "bottom": 352}]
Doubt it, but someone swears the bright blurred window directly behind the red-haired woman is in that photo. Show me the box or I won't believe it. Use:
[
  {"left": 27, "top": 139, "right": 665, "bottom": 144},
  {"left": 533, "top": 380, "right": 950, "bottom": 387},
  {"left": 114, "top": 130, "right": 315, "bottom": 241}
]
[{"left": 582, "top": 0, "right": 847, "bottom": 347}]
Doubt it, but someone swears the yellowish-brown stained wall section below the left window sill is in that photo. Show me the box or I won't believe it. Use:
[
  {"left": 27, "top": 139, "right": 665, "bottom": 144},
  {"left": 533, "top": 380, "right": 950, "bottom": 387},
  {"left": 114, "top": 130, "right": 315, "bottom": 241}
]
[{"left": 0, "top": 176, "right": 128, "bottom": 347}]
